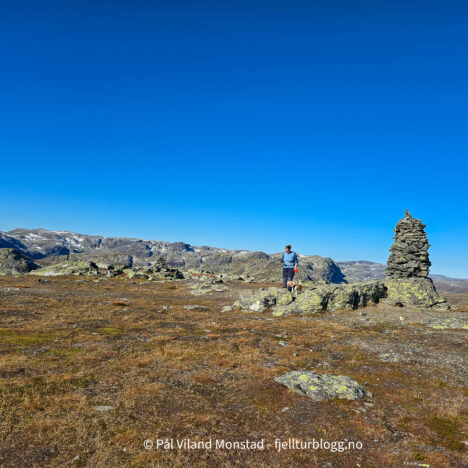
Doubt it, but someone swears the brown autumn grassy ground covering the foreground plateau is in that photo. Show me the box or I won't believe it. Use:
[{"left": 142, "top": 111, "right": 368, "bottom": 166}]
[{"left": 0, "top": 276, "right": 468, "bottom": 467}]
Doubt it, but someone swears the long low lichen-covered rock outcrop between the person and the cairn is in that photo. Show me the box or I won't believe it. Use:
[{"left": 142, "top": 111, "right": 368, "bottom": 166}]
[{"left": 234, "top": 281, "right": 386, "bottom": 317}]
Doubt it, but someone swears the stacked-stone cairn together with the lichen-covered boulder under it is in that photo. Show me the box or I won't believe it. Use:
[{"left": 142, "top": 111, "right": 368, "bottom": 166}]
[{"left": 385, "top": 210, "right": 449, "bottom": 309}]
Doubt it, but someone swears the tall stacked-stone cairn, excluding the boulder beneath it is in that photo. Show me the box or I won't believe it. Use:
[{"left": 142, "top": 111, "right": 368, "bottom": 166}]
[{"left": 386, "top": 210, "right": 431, "bottom": 278}]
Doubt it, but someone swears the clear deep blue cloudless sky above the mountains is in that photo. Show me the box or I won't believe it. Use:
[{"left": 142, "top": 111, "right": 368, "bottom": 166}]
[{"left": 0, "top": 0, "right": 468, "bottom": 277}]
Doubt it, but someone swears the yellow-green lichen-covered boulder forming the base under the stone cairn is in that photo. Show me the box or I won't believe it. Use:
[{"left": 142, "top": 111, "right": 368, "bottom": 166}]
[{"left": 385, "top": 278, "right": 450, "bottom": 309}]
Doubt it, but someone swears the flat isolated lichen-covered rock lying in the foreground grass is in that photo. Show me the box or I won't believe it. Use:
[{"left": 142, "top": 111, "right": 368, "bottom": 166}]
[{"left": 274, "top": 371, "right": 366, "bottom": 401}]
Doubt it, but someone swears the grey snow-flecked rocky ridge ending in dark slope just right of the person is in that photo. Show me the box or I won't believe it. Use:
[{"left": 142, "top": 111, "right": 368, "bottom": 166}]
[{"left": 0, "top": 229, "right": 343, "bottom": 283}]
